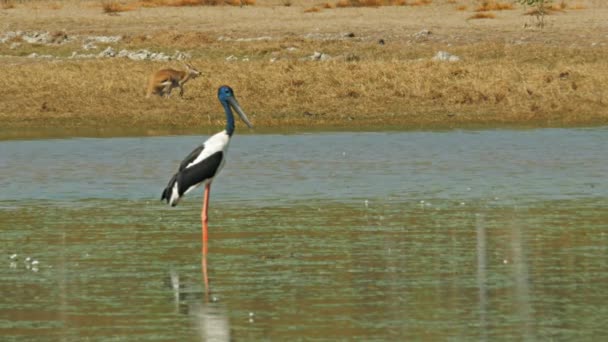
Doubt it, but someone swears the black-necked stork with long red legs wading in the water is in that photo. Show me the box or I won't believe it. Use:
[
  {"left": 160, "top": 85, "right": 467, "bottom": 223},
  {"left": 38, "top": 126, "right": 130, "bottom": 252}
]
[{"left": 161, "top": 86, "right": 253, "bottom": 248}]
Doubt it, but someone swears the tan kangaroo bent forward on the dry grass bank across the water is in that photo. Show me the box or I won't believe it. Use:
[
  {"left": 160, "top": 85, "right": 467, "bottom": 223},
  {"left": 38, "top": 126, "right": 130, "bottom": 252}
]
[{"left": 146, "top": 62, "right": 201, "bottom": 98}]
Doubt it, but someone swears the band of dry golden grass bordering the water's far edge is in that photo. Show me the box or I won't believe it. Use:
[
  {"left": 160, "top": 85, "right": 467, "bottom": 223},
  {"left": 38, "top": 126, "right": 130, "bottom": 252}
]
[{"left": 0, "top": 40, "right": 608, "bottom": 128}]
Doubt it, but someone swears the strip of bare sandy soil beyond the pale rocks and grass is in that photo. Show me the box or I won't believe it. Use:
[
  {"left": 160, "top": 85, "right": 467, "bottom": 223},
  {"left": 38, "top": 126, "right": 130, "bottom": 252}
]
[{"left": 0, "top": 0, "right": 608, "bottom": 46}]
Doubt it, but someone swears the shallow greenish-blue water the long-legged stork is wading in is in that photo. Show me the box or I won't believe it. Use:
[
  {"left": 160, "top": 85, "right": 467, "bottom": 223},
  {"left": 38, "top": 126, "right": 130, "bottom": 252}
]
[{"left": 0, "top": 128, "right": 608, "bottom": 341}]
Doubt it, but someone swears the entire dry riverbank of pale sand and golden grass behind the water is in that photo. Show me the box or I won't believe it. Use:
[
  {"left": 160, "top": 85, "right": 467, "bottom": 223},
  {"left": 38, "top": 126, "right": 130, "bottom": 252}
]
[{"left": 0, "top": 1, "right": 608, "bottom": 136}]
